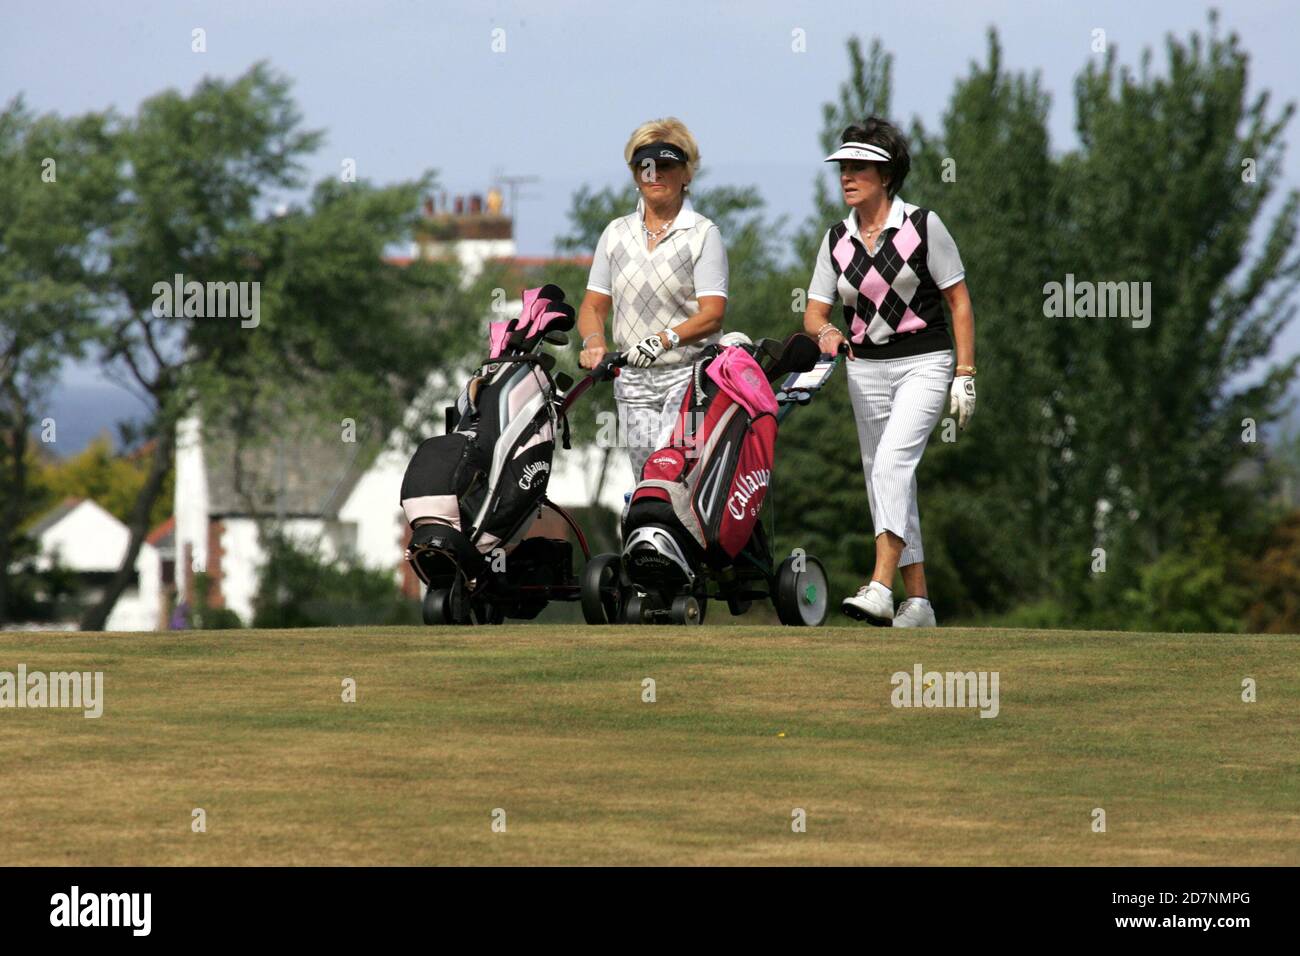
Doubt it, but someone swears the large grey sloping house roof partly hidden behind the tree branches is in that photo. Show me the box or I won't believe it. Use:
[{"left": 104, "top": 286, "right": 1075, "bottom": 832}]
[{"left": 203, "top": 421, "right": 378, "bottom": 518}]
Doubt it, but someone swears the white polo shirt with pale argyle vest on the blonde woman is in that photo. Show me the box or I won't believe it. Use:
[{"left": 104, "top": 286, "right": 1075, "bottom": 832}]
[{"left": 586, "top": 198, "right": 727, "bottom": 367}]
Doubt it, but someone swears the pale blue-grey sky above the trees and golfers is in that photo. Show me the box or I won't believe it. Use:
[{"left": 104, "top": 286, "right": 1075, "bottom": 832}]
[{"left": 0, "top": 0, "right": 1300, "bottom": 449}]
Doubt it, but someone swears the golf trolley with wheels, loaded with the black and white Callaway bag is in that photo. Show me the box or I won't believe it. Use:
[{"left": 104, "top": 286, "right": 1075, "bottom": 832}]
[{"left": 402, "top": 285, "right": 615, "bottom": 624}]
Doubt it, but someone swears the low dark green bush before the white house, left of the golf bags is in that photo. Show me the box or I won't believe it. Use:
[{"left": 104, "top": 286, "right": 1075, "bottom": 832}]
[{"left": 252, "top": 531, "right": 420, "bottom": 627}]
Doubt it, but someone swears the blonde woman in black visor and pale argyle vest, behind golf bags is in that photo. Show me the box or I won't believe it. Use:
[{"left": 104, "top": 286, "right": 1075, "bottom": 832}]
[{"left": 577, "top": 117, "right": 727, "bottom": 479}]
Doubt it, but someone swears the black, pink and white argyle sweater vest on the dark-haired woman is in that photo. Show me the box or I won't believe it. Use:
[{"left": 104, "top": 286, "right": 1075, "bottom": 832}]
[{"left": 828, "top": 207, "right": 952, "bottom": 359}]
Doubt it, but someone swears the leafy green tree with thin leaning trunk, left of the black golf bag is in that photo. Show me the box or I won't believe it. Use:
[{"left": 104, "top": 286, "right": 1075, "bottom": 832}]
[{"left": 82, "top": 64, "right": 475, "bottom": 630}]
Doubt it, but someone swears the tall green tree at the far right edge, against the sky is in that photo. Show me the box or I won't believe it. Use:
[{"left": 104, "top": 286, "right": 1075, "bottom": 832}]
[{"left": 1061, "top": 14, "right": 1300, "bottom": 613}]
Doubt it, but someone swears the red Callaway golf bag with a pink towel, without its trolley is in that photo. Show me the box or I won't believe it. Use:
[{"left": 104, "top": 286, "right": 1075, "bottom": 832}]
[{"left": 623, "top": 335, "right": 777, "bottom": 589}]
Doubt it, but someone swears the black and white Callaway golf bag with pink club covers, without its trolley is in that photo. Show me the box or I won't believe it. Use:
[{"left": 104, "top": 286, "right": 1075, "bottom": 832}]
[{"left": 402, "top": 285, "right": 573, "bottom": 605}]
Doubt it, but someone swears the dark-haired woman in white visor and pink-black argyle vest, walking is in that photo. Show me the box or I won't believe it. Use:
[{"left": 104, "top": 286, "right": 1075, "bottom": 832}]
[{"left": 803, "top": 117, "right": 975, "bottom": 627}]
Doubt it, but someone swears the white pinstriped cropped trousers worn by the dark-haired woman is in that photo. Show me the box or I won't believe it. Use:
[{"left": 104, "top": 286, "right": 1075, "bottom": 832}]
[{"left": 845, "top": 350, "right": 956, "bottom": 567}]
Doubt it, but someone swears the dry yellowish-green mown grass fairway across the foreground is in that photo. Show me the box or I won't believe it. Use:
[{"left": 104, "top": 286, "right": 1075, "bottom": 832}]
[{"left": 0, "top": 626, "right": 1300, "bottom": 865}]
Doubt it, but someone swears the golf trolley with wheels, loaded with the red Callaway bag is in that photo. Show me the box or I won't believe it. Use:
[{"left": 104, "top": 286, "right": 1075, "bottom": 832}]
[{"left": 581, "top": 334, "right": 840, "bottom": 627}]
